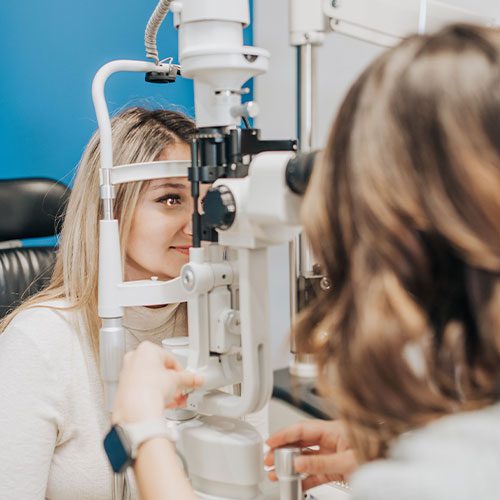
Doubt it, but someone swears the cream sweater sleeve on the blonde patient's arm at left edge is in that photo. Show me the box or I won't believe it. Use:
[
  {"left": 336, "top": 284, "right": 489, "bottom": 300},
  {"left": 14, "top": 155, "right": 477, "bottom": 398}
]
[{"left": 0, "top": 327, "right": 61, "bottom": 500}]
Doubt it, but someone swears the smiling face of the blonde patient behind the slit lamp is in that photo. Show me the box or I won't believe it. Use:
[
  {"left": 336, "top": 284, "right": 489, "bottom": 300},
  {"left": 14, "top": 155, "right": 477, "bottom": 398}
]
[{"left": 125, "top": 143, "right": 209, "bottom": 281}]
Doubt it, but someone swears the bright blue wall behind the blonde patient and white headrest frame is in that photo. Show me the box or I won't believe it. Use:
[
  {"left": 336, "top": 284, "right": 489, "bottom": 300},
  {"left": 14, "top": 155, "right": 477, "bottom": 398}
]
[{"left": 0, "top": 0, "right": 252, "bottom": 184}]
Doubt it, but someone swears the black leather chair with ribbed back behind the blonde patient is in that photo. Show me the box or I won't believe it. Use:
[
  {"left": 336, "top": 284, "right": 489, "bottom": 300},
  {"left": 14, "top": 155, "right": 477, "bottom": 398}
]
[{"left": 0, "top": 178, "right": 70, "bottom": 318}]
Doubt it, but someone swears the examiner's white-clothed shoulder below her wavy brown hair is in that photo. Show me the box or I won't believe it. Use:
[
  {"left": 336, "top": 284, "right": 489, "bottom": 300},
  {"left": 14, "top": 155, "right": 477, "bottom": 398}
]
[{"left": 350, "top": 403, "right": 500, "bottom": 500}]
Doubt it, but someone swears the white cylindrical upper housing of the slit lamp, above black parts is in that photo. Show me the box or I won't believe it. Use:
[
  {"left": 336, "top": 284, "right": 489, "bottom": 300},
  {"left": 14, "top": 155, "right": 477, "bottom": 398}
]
[{"left": 174, "top": 0, "right": 269, "bottom": 127}]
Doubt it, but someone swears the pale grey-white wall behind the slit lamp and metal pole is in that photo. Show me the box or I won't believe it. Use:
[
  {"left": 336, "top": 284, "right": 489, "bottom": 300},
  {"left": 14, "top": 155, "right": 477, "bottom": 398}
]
[{"left": 260, "top": 0, "right": 500, "bottom": 368}]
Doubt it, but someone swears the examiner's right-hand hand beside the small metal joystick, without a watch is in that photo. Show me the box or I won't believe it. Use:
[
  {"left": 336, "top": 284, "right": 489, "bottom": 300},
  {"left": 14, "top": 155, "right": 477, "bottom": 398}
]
[{"left": 264, "top": 420, "right": 358, "bottom": 491}]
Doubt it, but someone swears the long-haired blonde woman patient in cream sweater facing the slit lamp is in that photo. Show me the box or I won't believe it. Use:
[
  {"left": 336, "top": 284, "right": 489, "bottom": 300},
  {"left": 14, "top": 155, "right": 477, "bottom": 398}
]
[{"left": 0, "top": 108, "right": 206, "bottom": 500}]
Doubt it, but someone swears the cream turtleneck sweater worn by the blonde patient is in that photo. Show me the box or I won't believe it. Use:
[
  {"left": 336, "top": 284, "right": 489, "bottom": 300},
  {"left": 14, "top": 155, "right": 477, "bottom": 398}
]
[{"left": 0, "top": 301, "right": 187, "bottom": 500}]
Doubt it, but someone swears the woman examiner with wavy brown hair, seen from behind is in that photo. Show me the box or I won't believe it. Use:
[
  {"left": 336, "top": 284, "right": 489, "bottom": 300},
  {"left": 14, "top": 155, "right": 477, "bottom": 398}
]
[{"left": 114, "top": 25, "right": 500, "bottom": 500}]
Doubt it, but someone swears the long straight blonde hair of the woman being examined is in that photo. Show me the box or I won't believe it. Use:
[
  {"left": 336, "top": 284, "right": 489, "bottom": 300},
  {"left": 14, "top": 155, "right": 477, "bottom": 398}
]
[{"left": 0, "top": 107, "right": 195, "bottom": 356}]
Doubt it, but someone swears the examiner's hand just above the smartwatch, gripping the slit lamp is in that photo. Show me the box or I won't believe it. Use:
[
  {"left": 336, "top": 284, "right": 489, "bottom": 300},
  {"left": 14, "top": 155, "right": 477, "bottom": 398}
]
[{"left": 111, "top": 342, "right": 203, "bottom": 423}]
